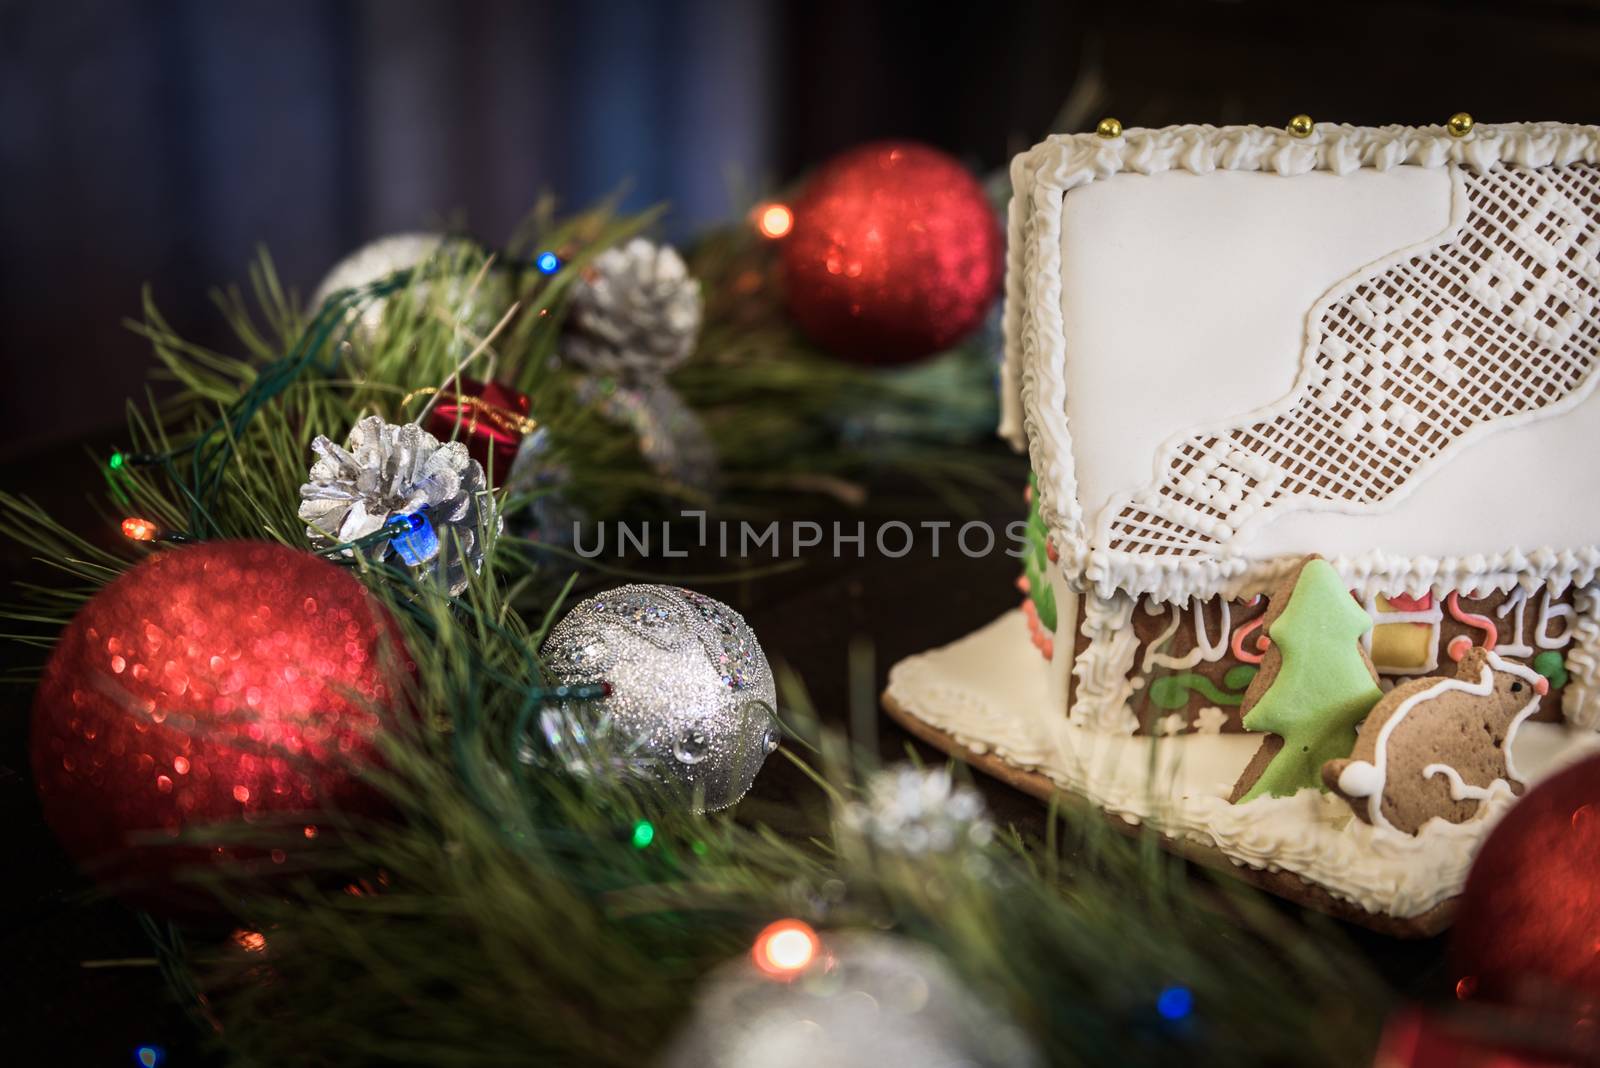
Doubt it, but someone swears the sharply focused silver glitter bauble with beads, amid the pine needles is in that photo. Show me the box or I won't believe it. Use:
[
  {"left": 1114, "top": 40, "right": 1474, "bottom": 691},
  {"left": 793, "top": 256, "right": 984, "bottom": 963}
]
[{"left": 542, "top": 585, "right": 779, "bottom": 811}]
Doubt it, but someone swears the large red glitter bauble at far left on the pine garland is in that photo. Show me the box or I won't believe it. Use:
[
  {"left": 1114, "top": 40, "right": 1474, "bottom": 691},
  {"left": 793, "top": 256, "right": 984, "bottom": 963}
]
[{"left": 32, "top": 542, "right": 410, "bottom": 907}]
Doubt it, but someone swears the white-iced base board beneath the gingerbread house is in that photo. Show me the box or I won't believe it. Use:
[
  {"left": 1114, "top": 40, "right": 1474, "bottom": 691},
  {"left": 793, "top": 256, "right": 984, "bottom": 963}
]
[{"left": 888, "top": 612, "right": 1600, "bottom": 916}]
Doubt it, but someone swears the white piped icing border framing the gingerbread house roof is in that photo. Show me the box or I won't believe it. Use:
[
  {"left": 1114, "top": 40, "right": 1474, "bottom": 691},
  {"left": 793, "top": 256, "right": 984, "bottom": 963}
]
[{"left": 1000, "top": 123, "right": 1600, "bottom": 601}]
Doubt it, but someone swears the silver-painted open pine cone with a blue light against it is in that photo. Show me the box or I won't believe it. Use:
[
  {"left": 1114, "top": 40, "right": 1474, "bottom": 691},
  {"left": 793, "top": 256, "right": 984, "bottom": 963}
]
[{"left": 299, "top": 416, "right": 504, "bottom": 593}]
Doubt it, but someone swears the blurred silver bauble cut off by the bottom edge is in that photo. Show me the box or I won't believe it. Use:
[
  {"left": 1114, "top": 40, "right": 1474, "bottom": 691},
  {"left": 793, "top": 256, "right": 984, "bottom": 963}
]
[{"left": 662, "top": 932, "right": 1040, "bottom": 1068}]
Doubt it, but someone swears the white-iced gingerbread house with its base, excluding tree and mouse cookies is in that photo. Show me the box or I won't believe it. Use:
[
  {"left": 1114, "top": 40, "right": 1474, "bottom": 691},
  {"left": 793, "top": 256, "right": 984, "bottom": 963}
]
[{"left": 886, "top": 117, "right": 1600, "bottom": 932}]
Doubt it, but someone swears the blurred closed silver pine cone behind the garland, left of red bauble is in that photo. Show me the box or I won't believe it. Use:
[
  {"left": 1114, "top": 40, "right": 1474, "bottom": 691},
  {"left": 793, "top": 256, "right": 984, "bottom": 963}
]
[{"left": 562, "top": 237, "right": 701, "bottom": 381}]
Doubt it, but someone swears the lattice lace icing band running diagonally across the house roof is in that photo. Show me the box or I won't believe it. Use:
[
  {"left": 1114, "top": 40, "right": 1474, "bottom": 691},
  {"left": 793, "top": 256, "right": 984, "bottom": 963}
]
[{"left": 1096, "top": 166, "right": 1600, "bottom": 555}]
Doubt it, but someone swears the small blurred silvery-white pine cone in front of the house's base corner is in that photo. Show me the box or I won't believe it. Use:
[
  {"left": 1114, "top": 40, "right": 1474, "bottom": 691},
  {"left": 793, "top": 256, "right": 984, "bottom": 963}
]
[{"left": 845, "top": 766, "right": 994, "bottom": 854}]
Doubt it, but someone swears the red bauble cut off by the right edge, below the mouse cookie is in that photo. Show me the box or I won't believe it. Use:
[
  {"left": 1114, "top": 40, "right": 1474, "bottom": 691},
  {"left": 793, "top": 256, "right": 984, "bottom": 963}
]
[{"left": 1453, "top": 756, "right": 1600, "bottom": 1015}]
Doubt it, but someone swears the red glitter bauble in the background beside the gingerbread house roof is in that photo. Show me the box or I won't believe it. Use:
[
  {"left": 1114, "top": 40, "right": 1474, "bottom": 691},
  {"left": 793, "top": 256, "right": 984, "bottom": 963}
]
[{"left": 784, "top": 142, "right": 1000, "bottom": 363}]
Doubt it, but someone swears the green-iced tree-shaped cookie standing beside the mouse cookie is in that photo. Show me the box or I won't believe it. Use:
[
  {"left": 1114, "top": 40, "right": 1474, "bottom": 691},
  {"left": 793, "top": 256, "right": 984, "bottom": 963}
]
[{"left": 1240, "top": 560, "right": 1382, "bottom": 801}]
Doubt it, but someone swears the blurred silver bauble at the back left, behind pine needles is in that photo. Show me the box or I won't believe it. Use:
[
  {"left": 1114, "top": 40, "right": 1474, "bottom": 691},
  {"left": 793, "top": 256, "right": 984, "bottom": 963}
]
[{"left": 306, "top": 232, "right": 510, "bottom": 345}]
